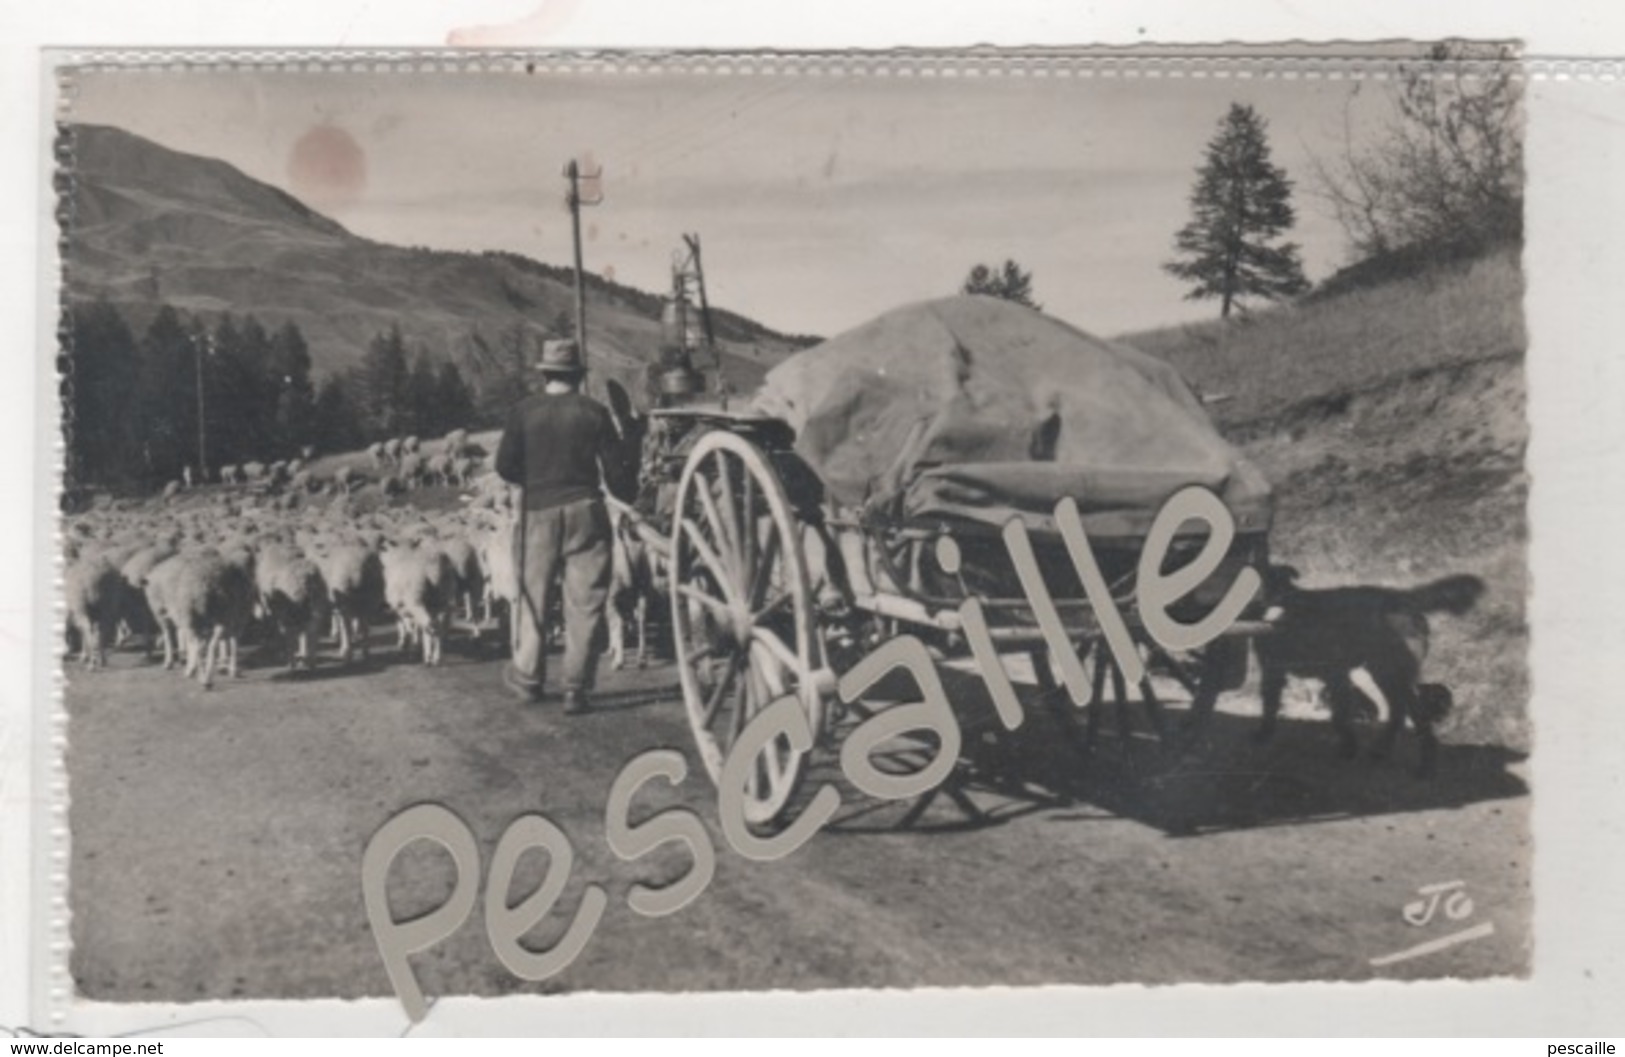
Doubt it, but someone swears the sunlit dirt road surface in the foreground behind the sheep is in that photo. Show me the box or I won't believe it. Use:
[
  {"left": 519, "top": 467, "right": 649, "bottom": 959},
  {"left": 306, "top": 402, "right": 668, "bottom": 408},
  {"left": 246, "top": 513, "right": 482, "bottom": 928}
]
[{"left": 67, "top": 624, "right": 1531, "bottom": 1002}]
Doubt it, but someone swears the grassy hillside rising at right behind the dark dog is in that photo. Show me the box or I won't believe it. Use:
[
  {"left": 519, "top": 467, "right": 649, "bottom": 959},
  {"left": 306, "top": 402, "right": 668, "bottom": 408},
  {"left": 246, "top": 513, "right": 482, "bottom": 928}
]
[{"left": 1123, "top": 254, "right": 1529, "bottom": 746}]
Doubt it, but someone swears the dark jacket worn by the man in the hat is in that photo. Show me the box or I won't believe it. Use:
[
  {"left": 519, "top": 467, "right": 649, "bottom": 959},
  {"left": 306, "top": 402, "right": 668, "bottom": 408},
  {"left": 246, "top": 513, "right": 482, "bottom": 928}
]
[{"left": 497, "top": 392, "right": 621, "bottom": 511}]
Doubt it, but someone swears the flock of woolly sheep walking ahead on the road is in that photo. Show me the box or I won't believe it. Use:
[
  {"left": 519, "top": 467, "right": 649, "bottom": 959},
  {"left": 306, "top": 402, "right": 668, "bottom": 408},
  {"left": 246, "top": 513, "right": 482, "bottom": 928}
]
[{"left": 63, "top": 431, "right": 647, "bottom": 688}]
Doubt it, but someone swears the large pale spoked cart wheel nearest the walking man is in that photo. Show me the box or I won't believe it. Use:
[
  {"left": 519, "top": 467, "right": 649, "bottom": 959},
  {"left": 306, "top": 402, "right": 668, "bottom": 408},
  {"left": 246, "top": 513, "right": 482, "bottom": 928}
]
[{"left": 671, "top": 429, "right": 822, "bottom": 826}]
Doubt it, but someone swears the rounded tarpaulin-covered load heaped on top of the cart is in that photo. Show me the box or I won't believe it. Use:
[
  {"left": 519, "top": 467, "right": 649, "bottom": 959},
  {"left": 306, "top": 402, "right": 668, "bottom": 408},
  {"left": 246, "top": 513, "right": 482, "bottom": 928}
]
[{"left": 756, "top": 296, "right": 1271, "bottom": 535}]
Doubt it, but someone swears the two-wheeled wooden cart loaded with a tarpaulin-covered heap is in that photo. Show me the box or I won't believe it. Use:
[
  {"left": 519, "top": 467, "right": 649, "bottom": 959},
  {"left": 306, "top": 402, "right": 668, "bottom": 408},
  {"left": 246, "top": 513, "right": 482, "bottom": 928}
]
[{"left": 607, "top": 298, "right": 1269, "bottom": 826}]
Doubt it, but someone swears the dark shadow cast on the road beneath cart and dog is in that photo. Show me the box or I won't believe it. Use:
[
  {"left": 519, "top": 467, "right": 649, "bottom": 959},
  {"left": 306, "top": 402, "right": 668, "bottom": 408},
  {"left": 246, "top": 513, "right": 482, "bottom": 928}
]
[{"left": 814, "top": 669, "right": 1529, "bottom": 837}]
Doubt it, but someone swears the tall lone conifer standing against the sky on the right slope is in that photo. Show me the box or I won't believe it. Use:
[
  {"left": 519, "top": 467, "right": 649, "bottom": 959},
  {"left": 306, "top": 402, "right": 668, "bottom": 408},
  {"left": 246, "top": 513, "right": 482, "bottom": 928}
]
[{"left": 1162, "top": 102, "right": 1308, "bottom": 319}]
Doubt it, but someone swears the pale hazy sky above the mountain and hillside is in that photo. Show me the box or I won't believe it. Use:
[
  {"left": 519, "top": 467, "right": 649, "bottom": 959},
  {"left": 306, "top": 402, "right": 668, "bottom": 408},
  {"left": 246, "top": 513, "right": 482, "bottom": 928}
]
[{"left": 67, "top": 62, "right": 1391, "bottom": 335}]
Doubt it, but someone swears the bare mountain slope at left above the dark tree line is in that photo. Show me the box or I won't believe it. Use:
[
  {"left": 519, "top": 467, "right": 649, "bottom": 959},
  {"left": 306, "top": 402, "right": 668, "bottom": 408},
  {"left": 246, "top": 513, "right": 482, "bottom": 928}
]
[{"left": 63, "top": 125, "right": 806, "bottom": 389}]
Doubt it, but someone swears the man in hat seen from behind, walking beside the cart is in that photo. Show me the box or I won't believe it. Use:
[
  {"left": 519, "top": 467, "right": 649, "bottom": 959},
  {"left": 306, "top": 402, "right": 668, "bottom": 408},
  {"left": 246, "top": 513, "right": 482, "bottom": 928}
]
[{"left": 496, "top": 341, "right": 621, "bottom": 716}]
